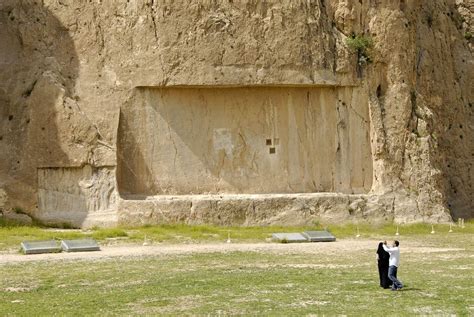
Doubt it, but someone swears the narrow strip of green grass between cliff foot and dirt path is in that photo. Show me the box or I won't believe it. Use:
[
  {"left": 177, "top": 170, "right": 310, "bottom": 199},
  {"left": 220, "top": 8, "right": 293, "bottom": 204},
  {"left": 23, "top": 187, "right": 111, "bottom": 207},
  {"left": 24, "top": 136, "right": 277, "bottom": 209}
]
[{"left": 0, "top": 218, "right": 474, "bottom": 251}]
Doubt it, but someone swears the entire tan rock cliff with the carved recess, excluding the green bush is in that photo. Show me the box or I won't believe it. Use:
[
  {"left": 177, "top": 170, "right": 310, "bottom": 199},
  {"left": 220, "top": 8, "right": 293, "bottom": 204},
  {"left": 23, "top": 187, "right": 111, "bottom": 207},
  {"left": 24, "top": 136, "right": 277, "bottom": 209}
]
[{"left": 0, "top": 0, "right": 474, "bottom": 226}]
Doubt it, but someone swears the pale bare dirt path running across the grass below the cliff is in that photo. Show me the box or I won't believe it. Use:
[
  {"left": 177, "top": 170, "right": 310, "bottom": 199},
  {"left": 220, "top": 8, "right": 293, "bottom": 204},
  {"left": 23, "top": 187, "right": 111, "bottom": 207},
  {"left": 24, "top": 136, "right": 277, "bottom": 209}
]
[{"left": 0, "top": 239, "right": 463, "bottom": 265}]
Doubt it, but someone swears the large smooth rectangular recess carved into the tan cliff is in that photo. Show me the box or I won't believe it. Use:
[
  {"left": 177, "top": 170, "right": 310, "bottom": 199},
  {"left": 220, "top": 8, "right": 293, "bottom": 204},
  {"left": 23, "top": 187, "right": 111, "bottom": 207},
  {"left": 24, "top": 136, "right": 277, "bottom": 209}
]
[{"left": 117, "top": 87, "right": 372, "bottom": 195}]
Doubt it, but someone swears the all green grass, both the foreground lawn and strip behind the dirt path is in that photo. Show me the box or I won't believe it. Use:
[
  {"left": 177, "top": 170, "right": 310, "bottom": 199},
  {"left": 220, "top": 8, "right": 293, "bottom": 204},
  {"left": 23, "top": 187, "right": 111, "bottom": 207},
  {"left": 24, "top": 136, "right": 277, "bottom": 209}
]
[{"left": 0, "top": 224, "right": 474, "bottom": 316}]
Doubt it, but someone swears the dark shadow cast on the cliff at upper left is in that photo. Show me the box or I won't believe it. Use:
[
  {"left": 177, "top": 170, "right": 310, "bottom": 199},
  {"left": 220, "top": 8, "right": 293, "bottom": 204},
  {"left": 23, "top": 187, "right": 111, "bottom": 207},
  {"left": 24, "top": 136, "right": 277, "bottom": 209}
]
[{"left": 0, "top": 0, "right": 78, "bottom": 213}]
